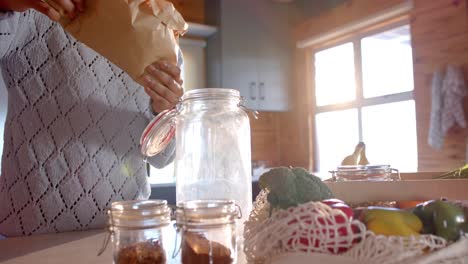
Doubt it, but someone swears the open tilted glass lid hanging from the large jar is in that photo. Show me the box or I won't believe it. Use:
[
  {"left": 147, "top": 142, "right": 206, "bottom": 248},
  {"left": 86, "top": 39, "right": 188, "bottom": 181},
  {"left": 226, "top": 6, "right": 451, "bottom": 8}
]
[{"left": 140, "top": 109, "right": 177, "bottom": 157}]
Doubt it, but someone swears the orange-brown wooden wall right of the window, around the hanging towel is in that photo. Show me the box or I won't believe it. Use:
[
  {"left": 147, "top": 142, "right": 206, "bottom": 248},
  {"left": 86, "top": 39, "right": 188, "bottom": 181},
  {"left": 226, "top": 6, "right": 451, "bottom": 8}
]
[{"left": 411, "top": 0, "right": 468, "bottom": 171}]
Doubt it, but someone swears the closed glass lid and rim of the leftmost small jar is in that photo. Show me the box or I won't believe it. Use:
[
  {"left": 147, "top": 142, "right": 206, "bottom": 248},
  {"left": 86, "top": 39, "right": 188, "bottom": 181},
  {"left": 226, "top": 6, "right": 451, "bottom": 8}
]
[{"left": 108, "top": 200, "right": 171, "bottom": 227}]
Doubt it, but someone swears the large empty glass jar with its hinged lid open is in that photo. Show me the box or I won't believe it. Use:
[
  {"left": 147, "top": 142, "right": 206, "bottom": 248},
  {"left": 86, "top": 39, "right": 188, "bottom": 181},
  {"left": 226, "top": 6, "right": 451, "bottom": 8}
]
[{"left": 140, "top": 88, "right": 252, "bottom": 225}]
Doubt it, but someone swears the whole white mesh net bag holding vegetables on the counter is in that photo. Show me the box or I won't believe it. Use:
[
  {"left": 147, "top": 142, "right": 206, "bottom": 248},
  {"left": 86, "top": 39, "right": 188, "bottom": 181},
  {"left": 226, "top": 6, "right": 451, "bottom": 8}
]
[{"left": 244, "top": 191, "right": 468, "bottom": 264}]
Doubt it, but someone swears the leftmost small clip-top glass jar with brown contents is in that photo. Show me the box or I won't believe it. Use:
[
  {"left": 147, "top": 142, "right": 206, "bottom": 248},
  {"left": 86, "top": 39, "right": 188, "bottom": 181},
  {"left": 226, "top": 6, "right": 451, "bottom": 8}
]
[{"left": 108, "top": 200, "right": 171, "bottom": 264}]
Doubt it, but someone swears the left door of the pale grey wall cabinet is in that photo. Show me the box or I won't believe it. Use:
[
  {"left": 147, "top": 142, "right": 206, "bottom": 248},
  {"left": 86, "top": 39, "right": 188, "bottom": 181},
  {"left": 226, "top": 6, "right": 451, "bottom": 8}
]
[{"left": 221, "top": 0, "right": 258, "bottom": 109}]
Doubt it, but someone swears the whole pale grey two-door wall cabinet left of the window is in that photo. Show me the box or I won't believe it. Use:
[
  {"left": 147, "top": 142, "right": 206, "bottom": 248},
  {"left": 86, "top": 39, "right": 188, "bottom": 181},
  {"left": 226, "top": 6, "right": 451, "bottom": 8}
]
[{"left": 206, "top": 0, "right": 292, "bottom": 111}]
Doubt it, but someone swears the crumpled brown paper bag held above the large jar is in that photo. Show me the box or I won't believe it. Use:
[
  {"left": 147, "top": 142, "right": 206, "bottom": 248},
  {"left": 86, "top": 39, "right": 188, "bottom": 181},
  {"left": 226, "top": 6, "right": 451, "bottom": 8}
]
[{"left": 61, "top": 0, "right": 188, "bottom": 83}]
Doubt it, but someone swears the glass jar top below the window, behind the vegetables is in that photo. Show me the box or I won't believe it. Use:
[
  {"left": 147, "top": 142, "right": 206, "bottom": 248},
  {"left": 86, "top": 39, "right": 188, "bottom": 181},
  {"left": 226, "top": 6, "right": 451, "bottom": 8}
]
[{"left": 331, "top": 165, "right": 400, "bottom": 181}]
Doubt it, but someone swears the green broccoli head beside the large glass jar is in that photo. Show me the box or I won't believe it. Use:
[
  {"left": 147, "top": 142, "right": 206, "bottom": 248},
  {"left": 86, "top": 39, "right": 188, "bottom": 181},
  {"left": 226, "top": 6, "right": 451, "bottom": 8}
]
[{"left": 259, "top": 167, "right": 333, "bottom": 213}]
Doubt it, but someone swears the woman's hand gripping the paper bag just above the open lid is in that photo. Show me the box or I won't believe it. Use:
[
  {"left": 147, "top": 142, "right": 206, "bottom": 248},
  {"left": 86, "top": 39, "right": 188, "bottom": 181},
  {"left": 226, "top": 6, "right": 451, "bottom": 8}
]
[{"left": 143, "top": 60, "right": 184, "bottom": 113}]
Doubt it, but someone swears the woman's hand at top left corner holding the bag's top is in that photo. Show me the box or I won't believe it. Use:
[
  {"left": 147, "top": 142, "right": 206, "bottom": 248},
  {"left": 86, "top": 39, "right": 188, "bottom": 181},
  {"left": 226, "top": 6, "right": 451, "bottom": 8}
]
[{"left": 0, "top": 0, "right": 85, "bottom": 21}]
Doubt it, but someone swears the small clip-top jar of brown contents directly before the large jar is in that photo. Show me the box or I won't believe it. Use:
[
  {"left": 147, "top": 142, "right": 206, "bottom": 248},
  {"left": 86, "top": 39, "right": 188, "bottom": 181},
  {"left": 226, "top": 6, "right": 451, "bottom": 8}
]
[{"left": 176, "top": 200, "right": 241, "bottom": 264}]
